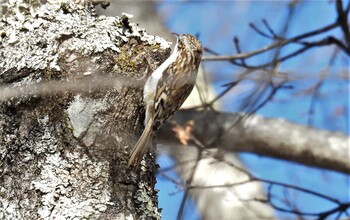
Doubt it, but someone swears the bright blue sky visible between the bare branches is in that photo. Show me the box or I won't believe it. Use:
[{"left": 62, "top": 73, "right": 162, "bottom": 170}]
[{"left": 157, "top": 0, "right": 350, "bottom": 220}]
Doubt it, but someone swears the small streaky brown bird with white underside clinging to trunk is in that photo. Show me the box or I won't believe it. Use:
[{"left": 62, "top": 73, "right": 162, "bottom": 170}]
[{"left": 128, "top": 34, "right": 202, "bottom": 166}]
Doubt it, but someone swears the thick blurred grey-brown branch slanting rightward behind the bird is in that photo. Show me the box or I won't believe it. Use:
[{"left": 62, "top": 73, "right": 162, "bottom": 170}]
[{"left": 157, "top": 110, "right": 350, "bottom": 174}]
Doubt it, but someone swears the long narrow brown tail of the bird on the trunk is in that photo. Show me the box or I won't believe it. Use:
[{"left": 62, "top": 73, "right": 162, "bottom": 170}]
[{"left": 128, "top": 122, "right": 153, "bottom": 166}]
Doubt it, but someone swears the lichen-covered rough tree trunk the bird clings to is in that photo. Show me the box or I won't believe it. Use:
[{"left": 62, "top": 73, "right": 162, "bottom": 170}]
[{"left": 0, "top": 1, "right": 170, "bottom": 219}]
